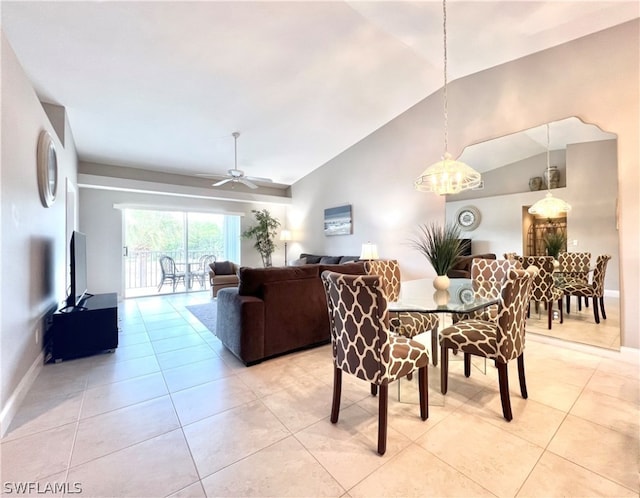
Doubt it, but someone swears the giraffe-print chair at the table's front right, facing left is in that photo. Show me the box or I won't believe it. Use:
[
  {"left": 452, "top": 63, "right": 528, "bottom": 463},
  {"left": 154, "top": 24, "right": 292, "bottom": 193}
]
[{"left": 440, "top": 269, "right": 535, "bottom": 422}]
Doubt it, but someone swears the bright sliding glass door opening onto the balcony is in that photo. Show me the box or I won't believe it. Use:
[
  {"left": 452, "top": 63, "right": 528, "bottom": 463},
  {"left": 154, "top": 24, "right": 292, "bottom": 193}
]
[{"left": 123, "top": 209, "right": 240, "bottom": 297}]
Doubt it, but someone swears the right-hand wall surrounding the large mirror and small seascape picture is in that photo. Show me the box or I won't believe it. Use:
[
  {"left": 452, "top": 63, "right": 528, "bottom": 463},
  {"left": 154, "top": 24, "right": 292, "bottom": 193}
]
[{"left": 290, "top": 20, "right": 640, "bottom": 348}]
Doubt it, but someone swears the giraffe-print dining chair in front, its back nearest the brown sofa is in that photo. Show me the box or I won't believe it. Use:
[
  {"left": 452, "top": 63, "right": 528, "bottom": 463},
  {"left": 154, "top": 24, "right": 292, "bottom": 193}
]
[{"left": 322, "top": 271, "right": 429, "bottom": 455}]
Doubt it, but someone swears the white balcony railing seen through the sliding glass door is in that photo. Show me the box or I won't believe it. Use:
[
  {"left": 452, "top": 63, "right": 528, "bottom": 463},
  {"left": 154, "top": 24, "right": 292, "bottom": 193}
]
[{"left": 124, "top": 250, "right": 221, "bottom": 296}]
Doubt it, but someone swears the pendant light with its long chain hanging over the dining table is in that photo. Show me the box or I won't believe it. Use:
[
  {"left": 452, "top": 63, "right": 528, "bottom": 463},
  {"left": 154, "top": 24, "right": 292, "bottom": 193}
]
[{"left": 413, "top": 0, "right": 480, "bottom": 195}]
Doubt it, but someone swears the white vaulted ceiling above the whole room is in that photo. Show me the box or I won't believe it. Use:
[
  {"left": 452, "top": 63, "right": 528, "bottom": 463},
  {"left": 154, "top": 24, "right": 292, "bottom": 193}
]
[{"left": 1, "top": 0, "right": 639, "bottom": 185}]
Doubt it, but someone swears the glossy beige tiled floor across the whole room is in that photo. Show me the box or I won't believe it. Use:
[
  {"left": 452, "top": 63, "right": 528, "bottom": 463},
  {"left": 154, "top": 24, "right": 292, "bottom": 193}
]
[{"left": 1, "top": 293, "right": 640, "bottom": 497}]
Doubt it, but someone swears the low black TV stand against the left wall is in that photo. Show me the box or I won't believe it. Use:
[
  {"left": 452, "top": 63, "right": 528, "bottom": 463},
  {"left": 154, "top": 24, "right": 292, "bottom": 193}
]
[{"left": 47, "top": 292, "right": 118, "bottom": 362}]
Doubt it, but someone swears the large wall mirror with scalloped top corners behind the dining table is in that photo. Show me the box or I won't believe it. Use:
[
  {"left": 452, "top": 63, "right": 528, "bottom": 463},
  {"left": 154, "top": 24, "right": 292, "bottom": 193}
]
[{"left": 446, "top": 117, "right": 620, "bottom": 350}]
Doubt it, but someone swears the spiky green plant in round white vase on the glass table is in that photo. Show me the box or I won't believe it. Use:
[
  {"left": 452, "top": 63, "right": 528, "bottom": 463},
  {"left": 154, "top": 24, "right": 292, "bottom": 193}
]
[{"left": 413, "top": 223, "right": 462, "bottom": 290}]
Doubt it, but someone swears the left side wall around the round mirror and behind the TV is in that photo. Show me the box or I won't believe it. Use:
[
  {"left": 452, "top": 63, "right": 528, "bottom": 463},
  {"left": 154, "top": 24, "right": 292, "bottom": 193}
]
[{"left": 0, "top": 34, "right": 77, "bottom": 433}]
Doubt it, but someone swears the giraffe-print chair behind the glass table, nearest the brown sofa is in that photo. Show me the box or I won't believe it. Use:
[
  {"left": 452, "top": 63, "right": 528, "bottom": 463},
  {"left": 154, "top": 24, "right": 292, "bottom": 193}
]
[{"left": 365, "top": 259, "right": 440, "bottom": 366}]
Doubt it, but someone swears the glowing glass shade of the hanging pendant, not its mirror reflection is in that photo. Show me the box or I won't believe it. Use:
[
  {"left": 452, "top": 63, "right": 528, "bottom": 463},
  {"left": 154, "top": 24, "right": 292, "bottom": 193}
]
[{"left": 414, "top": 152, "right": 481, "bottom": 195}]
